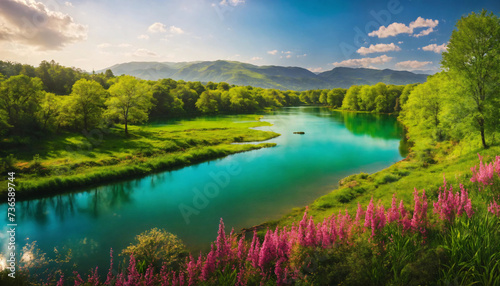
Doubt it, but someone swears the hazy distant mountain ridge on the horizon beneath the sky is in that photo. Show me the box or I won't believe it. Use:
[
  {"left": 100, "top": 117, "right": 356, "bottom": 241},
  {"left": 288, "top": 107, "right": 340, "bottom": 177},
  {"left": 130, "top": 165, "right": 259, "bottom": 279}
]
[{"left": 100, "top": 60, "right": 428, "bottom": 91}]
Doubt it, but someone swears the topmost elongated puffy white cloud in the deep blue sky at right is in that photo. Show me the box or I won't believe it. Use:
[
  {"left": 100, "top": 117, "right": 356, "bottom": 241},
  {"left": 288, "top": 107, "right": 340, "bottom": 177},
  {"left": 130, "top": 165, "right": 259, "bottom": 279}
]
[{"left": 368, "top": 17, "right": 439, "bottom": 38}]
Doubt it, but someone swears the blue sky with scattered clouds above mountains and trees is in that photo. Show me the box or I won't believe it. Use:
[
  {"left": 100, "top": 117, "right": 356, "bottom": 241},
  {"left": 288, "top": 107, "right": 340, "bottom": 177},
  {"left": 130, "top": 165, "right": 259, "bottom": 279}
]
[{"left": 0, "top": 0, "right": 500, "bottom": 72}]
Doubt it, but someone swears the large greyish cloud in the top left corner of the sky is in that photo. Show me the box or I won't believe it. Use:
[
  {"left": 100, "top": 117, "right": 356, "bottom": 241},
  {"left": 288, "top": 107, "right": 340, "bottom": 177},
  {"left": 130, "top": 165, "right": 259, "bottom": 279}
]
[{"left": 0, "top": 0, "right": 87, "bottom": 50}]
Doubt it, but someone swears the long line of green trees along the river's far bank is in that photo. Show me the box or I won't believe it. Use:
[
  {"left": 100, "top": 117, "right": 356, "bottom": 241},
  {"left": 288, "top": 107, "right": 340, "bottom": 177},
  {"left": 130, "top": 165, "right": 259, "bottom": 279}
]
[{"left": 0, "top": 57, "right": 414, "bottom": 139}]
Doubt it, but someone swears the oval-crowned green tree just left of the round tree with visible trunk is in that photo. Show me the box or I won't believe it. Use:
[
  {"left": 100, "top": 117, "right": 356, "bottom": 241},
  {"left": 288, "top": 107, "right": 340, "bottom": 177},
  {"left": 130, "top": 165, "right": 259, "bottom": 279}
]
[{"left": 71, "top": 79, "right": 106, "bottom": 130}]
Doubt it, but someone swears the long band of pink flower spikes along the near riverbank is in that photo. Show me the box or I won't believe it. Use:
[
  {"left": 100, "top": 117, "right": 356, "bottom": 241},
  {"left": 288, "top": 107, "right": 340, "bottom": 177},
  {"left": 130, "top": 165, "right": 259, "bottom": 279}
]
[{"left": 59, "top": 190, "right": 434, "bottom": 286}]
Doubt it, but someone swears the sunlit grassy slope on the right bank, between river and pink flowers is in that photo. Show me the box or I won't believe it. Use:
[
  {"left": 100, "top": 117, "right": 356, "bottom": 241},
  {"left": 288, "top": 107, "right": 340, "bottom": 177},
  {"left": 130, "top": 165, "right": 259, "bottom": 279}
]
[{"left": 262, "top": 143, "right": 500, "bottom": 230}]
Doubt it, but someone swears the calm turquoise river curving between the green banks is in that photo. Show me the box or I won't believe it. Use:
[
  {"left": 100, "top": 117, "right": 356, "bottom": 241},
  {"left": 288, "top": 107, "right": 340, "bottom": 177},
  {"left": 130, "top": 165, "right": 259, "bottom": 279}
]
[{"left": 0, "top": 107, "right": 405, "bottom": 274}]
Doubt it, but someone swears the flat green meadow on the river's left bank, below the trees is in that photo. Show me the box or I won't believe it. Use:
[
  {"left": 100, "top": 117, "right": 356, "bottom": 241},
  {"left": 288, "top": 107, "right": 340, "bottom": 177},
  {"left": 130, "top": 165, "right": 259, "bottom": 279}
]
[{"left": 0, "top": 115, "right": 279, "bottom": 198}]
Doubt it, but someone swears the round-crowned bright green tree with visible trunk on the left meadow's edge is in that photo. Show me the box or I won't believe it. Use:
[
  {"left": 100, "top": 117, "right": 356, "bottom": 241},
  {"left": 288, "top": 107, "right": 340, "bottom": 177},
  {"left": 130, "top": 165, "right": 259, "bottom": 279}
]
[{"left": 105, "top": 75, "right": 153, "bottom": 135}]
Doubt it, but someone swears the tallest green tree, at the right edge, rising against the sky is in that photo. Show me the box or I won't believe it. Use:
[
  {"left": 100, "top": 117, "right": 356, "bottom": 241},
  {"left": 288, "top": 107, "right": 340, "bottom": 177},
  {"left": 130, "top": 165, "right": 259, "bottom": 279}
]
[{"left": 441, "top": 10, "right": 500, "bottom": 148}]
